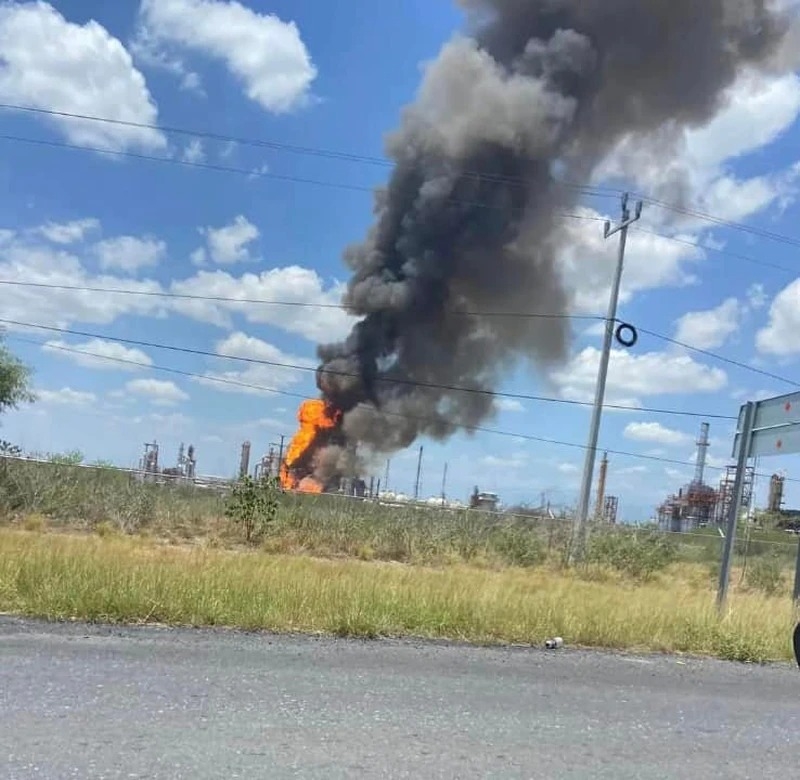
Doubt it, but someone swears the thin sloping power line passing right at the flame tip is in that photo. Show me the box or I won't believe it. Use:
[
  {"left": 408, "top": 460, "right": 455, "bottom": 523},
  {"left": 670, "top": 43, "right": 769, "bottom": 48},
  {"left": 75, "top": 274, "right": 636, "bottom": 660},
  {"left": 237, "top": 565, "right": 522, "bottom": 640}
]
[{"left": 10, "top": 335, "right": 780, "bottom": 482}]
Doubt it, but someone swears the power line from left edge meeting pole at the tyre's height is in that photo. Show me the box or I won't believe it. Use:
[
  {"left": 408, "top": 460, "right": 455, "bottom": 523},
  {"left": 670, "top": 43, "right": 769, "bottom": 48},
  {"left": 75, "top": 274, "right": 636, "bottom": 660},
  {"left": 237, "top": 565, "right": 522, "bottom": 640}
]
[{"left": 0, "top": 279, "right": 604, "bottom": 322}]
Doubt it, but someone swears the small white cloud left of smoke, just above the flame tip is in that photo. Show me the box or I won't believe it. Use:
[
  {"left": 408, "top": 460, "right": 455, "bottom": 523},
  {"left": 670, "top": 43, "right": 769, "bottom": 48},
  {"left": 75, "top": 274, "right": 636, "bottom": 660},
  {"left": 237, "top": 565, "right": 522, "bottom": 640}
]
[{"left": 196, "top": 333, "right": 317, "bottom": 395}]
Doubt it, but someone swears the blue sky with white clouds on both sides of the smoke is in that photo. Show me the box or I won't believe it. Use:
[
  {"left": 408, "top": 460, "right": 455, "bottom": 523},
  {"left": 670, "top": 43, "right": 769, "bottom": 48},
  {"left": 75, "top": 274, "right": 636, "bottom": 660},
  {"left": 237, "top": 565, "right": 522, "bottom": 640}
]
[{"left": 0, "top": 0, "right": 800, "bottom": 520}]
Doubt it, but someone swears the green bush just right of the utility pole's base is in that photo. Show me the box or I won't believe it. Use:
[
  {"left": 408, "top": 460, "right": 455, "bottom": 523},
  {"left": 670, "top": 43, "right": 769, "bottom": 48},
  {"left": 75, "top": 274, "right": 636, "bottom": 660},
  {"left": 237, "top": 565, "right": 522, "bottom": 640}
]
[{"left": 586, "top": 531, "right": 677, "bottom": 580}]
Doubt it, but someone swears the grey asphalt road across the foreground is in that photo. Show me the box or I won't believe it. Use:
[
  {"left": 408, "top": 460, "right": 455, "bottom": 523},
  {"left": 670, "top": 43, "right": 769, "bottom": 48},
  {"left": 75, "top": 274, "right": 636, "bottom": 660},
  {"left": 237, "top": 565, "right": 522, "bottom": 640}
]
[{"left": 0, "top": 618, "right": 800, "bottom": 780}]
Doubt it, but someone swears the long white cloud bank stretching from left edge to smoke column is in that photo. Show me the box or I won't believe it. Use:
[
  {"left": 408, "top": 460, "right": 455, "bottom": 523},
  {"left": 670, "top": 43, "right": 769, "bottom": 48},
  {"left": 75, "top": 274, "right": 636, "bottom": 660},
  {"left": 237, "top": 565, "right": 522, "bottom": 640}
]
[{"left": 0, "top": 218, "right": 355, "bottom": 343}]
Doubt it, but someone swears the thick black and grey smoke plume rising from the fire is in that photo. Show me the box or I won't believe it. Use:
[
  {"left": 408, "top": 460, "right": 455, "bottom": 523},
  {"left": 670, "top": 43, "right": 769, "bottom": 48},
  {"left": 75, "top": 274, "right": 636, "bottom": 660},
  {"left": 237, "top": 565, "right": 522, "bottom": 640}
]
[{"left": 310, "top": 0, "right": 788, "bottom": 478}]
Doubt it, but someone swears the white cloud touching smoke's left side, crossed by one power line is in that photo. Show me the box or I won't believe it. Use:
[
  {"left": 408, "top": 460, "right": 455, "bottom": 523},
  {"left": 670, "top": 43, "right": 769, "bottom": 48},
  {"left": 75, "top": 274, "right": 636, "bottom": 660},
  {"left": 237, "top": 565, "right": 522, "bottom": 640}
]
[{"left": 170, "top": 266, "right": 355, "bottom": 343}]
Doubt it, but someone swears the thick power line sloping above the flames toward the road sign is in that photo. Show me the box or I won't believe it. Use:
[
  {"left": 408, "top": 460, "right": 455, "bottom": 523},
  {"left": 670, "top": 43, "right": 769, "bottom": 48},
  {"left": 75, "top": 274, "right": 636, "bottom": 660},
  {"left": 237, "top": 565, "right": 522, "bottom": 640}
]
[{"left": 0, "top": 319, "right": 737, "bottom": 420}]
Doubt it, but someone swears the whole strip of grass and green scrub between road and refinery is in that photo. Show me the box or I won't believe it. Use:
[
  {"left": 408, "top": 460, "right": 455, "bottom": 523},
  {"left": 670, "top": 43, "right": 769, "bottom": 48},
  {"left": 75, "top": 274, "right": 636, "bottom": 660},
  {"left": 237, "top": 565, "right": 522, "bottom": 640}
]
[{"left": 0, "top": 466, "right": 793, "bottom": 661}]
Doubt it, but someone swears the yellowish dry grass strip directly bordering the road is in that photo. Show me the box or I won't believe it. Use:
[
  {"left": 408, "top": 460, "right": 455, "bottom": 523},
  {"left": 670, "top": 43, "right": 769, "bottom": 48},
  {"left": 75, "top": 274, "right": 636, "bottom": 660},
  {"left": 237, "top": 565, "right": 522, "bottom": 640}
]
[{"left": 0, "top": 529, "right": 793, "bottom": 662}]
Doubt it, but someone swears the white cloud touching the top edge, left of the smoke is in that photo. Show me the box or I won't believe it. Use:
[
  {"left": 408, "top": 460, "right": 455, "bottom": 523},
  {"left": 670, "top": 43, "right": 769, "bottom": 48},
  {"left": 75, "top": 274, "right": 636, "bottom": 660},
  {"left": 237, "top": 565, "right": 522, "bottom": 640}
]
[{"left": 141, "top": 0, "right": 317, "bottom": 113}]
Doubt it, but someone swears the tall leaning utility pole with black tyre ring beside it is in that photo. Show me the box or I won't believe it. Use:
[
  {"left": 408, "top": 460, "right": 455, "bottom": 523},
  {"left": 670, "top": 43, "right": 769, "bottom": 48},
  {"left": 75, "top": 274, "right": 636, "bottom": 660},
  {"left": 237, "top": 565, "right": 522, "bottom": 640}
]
[{"left": 570, "top": 192, "right": 642, "bottom": 562}]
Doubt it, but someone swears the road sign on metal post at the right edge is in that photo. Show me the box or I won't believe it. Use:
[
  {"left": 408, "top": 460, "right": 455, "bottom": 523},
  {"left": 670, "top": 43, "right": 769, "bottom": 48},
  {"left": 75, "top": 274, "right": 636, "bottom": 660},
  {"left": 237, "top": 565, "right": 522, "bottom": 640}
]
[{"left": 718, "top": 393, "right": 800, "bottom": 612}]
